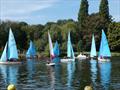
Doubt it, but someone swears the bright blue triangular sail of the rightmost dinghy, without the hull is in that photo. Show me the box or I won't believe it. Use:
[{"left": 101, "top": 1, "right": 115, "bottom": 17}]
[{"left": 99, "top": 30, "right": 111, "bottom": 57}]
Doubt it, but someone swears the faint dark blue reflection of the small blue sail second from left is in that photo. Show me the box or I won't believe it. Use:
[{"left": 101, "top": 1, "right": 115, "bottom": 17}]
[{"left": 27, "top": 59, "right": 35, "bottom": 78}]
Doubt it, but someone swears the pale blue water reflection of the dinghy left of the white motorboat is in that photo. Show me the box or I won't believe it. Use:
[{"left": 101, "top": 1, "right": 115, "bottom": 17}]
[{"left": 67, "top": 62, "right": 75, "bottom": 87}]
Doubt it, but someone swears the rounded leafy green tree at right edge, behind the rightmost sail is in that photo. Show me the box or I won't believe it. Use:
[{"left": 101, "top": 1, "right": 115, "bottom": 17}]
[{"left": 107, "top": 22, "right": 120, "bottom": 51}]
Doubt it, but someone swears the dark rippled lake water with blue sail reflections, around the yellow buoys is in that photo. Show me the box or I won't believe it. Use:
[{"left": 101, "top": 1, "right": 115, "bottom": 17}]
[{"left": 0, "top": 57, "right": 120, "bottom": 90}]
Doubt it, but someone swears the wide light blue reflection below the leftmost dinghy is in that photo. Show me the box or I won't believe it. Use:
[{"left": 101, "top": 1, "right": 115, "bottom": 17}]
[{"left": 0, "top": 65, "right": 18, "bottom": 84}]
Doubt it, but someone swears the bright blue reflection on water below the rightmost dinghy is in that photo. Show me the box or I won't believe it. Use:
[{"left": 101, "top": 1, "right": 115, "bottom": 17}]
[{"left": 99, "top": 62, "right": 111, "bottom": 90}]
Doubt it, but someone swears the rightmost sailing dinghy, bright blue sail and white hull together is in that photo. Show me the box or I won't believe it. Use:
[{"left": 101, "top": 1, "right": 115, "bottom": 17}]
[{"left": 98, "top": 30, "right": 111, "bottom": 61}]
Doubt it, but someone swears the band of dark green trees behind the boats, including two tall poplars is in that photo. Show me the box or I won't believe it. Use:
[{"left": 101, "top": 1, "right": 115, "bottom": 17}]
[{"left": 0, "top": 0, "right": 120, "bottom": 55}]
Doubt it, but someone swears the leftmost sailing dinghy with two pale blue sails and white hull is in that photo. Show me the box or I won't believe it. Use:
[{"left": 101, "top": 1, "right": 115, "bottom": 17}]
[{"left": 0, "top": 29, "right": 21, "bottom": 64}]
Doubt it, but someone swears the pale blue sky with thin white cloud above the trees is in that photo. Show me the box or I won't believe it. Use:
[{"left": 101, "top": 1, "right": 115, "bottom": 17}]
[{"left": 0, "top": 0, "right": 120, "bottom": 24}]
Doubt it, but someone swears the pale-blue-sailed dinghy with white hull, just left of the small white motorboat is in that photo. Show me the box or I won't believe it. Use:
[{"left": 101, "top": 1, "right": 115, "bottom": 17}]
[{"left": 61, "top": 32, "right": 75, "bottom": 62}]
